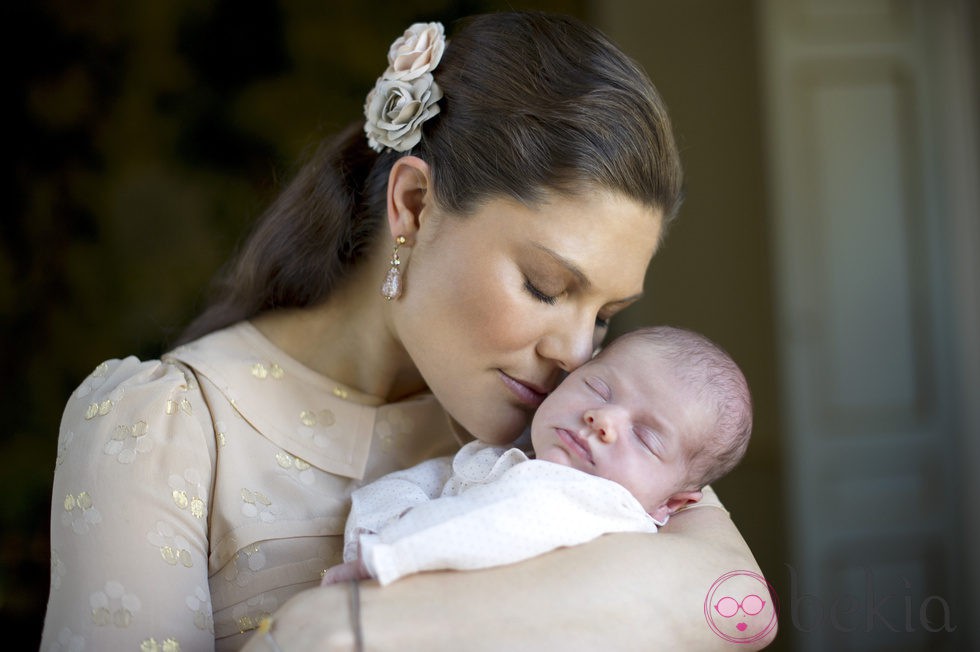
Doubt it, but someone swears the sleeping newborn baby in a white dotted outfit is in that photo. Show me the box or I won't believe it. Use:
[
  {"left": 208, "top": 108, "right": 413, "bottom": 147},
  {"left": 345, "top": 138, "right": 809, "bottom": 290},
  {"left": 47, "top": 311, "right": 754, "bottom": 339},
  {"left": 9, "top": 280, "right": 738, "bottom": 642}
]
[{"left": 323, "top": 326, "right": 752, "bottom": 584}]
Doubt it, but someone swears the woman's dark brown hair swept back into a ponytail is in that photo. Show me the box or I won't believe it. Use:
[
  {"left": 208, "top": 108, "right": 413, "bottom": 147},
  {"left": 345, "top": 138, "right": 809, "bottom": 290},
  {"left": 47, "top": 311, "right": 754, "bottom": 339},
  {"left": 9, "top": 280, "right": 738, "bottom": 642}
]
[{"left": 180, "top": 12, "right": 682, "bottom": 342}]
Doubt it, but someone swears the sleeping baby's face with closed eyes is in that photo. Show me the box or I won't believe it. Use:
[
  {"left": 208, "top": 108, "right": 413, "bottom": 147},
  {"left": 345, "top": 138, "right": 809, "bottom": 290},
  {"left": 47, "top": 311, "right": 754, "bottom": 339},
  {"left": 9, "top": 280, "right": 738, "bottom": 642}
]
[{"left": 531, "top": 340, "right": 703, "bottom": 520}]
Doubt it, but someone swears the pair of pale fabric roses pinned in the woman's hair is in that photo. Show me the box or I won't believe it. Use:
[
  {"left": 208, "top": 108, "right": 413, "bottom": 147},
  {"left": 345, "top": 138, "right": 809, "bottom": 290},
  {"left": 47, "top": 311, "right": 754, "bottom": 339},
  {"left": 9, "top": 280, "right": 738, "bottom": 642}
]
[{"left": 364, "top": 23, "right": 446, "bottom": 153}]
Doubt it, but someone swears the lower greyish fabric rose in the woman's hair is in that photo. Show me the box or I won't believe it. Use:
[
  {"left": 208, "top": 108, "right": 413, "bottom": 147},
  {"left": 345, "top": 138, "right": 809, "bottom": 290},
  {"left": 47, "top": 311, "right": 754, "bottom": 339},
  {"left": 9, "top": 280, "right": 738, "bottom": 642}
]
[{"left": 364, "top": 73, "right": 442, "bottom": 152}]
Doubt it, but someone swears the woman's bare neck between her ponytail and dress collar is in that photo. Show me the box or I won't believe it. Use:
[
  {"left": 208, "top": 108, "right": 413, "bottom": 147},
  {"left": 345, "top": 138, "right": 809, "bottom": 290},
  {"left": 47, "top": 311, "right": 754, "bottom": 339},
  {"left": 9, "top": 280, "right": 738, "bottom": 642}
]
[{"left": 252, "top": 265, "right": 425, "bottom": 402}]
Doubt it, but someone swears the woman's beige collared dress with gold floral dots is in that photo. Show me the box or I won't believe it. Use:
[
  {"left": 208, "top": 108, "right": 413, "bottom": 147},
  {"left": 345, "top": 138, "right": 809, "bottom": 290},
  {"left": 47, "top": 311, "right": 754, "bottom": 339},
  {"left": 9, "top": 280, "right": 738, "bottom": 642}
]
[{"left": 41, "top": 322, "right": 459, "bottom": 651}]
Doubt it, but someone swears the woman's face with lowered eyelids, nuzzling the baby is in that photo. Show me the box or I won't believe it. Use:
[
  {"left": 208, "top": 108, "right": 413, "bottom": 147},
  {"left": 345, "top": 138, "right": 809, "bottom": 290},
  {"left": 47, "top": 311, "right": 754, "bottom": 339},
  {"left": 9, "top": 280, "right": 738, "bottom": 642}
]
[{"left": 391, "top": 192, "right": 662, "bottom": 444}]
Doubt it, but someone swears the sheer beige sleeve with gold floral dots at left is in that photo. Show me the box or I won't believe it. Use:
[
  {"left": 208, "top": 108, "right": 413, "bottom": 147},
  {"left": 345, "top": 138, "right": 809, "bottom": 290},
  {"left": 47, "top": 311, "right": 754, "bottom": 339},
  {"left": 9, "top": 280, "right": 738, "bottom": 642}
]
[{"left": 41, "top": 358, "right": 215, "bottom": 652}]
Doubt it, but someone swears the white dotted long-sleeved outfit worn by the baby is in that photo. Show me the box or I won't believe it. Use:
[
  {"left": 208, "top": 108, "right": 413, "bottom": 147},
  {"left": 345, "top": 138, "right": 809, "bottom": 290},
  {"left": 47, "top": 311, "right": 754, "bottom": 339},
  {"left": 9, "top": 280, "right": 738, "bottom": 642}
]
[{"left": 344, "top": 442, "right": 657, "bottom": 584}]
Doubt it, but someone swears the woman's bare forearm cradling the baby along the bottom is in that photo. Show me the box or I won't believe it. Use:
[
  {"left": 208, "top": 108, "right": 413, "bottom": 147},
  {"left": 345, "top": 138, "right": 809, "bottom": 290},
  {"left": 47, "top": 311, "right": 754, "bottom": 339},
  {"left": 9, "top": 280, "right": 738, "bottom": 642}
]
[{"left": 245, "top": 508, "right": 776, "bottom": 652}]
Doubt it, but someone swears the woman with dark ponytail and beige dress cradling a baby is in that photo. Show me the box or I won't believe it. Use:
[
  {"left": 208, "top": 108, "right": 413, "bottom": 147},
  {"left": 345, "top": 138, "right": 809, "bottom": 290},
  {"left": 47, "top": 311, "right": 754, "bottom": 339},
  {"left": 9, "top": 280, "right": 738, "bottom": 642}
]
[{"left": 42, "top": 14, "right": 772, "bottom": 650}]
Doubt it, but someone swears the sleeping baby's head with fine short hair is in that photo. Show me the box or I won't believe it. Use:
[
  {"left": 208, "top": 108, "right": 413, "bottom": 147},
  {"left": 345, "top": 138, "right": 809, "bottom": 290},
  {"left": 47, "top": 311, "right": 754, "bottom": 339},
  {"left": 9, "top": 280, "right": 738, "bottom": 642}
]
[{"left": 531, "top": 326, "right": 752, "bottom": 521}]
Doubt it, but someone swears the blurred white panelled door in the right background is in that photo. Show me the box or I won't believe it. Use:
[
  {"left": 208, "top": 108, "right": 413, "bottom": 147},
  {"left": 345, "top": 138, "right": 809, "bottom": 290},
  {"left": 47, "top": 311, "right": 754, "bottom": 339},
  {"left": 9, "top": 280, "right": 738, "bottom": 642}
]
[{"left": 759, "top": 0, "right": 980, "bottom": 651}]
